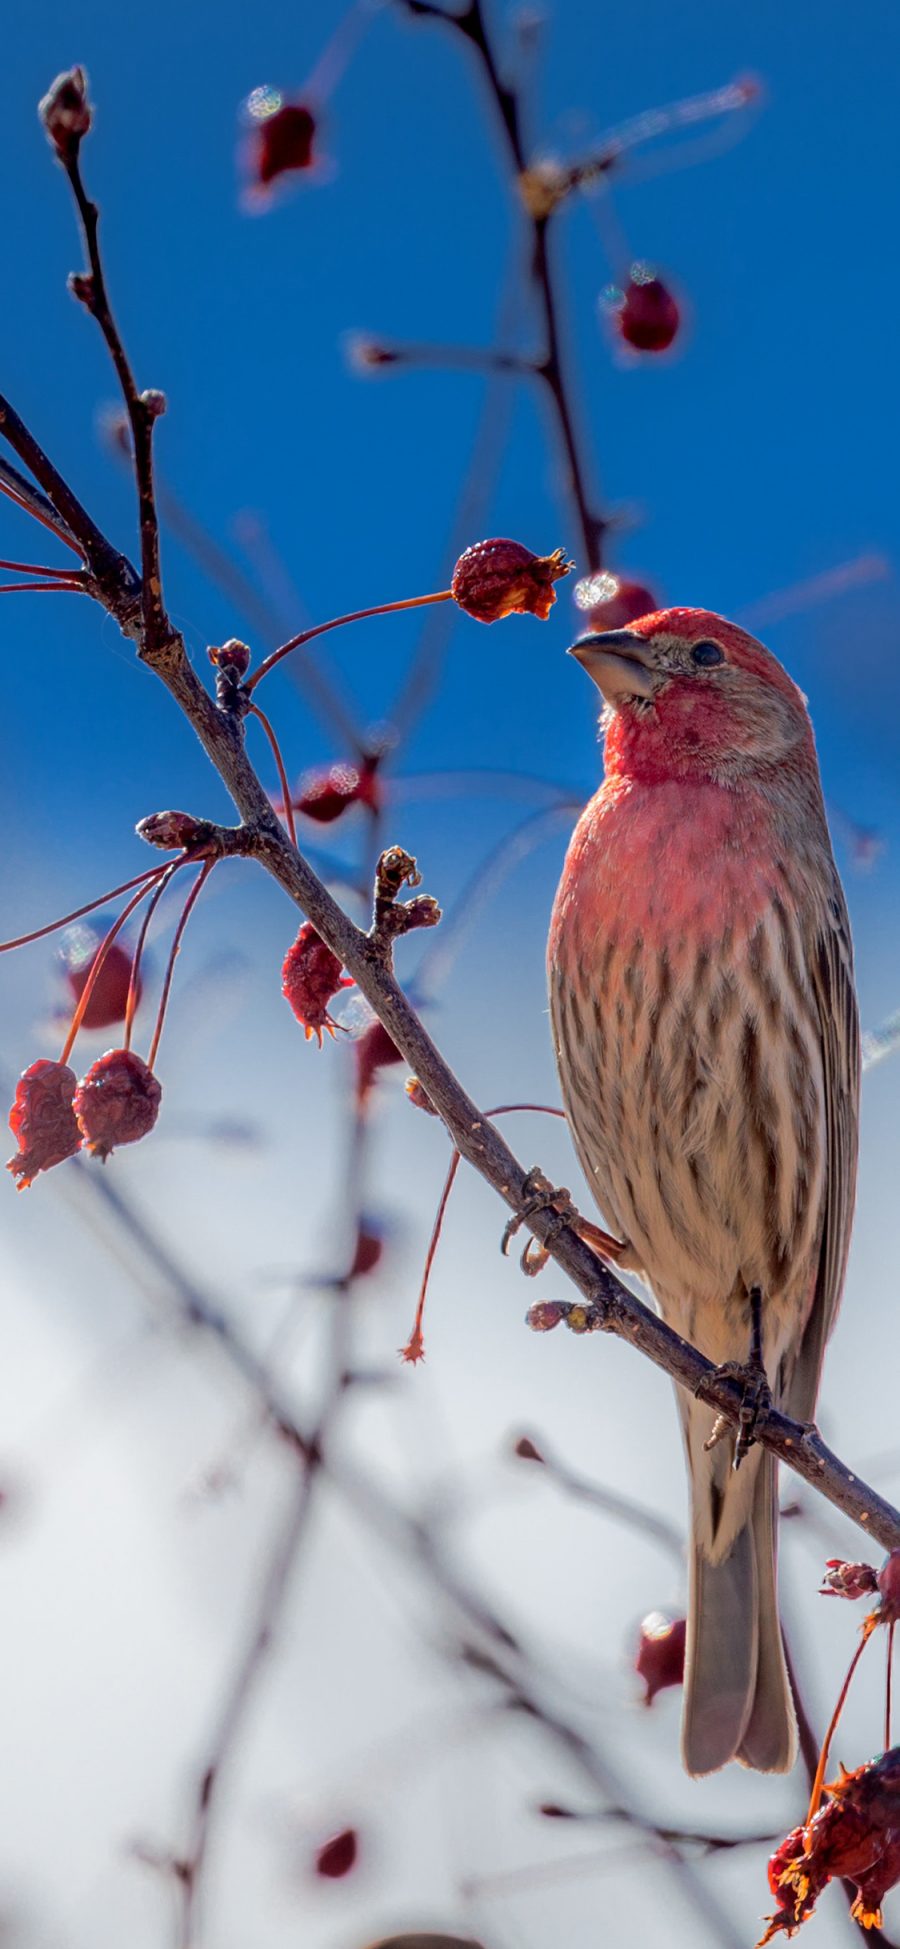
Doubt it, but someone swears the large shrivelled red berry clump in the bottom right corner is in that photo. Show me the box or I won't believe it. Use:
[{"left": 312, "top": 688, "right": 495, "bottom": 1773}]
[{"left": 758, "top": 1746, "right": 900, "bottom": 1949}]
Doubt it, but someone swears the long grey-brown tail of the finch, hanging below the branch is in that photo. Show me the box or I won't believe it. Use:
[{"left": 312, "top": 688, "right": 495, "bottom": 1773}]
[{"left": 682, "top": 1401, "right": 797, "bottom": 1774}]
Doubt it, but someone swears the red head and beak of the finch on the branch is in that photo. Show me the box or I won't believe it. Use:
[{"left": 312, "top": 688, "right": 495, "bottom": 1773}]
[{"left": 571, "top": 608, "right": 814, "bottom": 783}]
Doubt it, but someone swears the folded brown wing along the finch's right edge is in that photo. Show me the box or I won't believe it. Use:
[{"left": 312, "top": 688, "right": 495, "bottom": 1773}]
[{"left": 787, "top": 873, "right": 859, "bottom": 1421}]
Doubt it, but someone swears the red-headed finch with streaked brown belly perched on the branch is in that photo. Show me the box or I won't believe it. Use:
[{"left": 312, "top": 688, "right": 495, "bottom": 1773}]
[{"left": 549, "top": 608, "right": 859, "bottom": 1774}]
